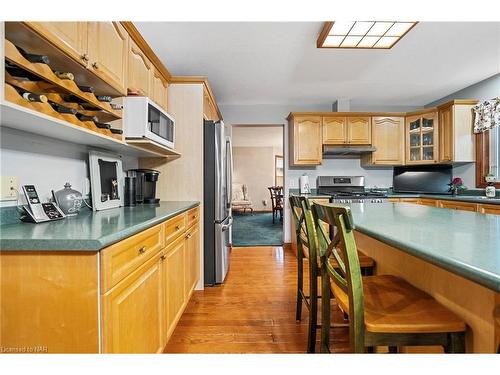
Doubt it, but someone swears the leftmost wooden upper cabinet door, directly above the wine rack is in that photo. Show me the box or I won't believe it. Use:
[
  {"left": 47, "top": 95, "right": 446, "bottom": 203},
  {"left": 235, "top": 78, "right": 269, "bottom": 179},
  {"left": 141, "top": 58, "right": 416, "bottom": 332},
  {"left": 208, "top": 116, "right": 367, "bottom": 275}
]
[{"left": 26, "top": 22, "right": 89, "bottom": 66}]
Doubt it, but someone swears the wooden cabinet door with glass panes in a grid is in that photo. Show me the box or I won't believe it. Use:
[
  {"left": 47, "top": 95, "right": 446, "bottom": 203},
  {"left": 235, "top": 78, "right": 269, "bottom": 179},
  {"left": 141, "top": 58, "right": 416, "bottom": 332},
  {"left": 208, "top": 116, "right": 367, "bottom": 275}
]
[{"left": 406, "top": 111, "right": 439, "bottom": 164}]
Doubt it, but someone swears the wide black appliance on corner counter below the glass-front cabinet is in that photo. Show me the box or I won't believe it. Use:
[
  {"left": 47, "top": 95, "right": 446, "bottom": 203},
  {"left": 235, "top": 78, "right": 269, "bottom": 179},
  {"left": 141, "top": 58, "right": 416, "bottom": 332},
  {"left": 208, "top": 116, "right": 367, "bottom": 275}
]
[{"left": 392, "top": 165, "right": 453, "bottom": 194}]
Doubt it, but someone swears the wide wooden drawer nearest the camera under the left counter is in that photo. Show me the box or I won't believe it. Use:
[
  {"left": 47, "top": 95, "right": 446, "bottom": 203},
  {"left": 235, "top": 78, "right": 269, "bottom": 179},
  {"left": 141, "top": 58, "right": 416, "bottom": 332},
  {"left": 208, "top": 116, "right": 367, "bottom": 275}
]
[{"left": 101, "top": 224, "right": 164, "bottom": 293}]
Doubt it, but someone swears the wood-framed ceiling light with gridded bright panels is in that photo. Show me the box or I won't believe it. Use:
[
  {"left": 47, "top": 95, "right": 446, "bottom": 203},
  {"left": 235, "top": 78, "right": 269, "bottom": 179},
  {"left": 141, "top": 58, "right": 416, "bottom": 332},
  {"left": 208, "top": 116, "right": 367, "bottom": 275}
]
[{"left": 317, "top": 21, "right": 417, "bottom": 49}]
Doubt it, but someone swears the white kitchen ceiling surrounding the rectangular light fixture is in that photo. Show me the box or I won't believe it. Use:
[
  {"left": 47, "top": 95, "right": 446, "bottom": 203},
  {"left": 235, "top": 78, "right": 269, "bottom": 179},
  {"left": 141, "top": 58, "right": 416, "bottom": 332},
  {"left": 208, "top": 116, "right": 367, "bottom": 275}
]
[{"left": 136, "top": 22, "right": 500, "bottom": 106}]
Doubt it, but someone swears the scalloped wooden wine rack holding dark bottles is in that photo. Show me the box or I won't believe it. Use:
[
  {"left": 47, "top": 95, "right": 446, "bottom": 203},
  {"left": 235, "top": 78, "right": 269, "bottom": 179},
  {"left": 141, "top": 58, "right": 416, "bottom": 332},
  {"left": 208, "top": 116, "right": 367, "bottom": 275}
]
[{"left": 5, "top": 39, "right": 123, "bottom": 141}]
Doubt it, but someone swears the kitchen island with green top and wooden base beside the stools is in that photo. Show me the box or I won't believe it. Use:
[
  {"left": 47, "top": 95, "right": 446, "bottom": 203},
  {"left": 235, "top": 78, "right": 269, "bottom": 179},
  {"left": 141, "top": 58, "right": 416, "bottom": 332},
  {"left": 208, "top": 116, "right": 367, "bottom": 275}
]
[{"left": 351, "top": 203, "right": 500, "bottom": 353}]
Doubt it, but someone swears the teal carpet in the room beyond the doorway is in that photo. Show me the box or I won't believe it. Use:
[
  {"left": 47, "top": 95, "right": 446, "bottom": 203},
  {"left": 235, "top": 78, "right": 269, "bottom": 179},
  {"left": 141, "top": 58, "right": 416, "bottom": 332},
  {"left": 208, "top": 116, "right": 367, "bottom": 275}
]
[{"left": 232, "top": 212, "right": 283, "bottom": 247}]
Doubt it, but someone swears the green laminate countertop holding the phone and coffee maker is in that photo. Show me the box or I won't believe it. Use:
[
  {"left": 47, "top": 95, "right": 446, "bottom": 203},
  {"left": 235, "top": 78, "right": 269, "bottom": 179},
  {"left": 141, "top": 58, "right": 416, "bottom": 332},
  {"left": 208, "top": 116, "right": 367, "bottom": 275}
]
[{"left": 0, "top": 201, "right": 199, "bottom": 251}]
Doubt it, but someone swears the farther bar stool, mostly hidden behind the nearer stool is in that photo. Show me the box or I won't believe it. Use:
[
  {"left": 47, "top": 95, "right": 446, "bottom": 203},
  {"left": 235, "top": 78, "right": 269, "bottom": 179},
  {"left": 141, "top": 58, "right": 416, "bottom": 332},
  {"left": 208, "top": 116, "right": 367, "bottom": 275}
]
[{"left": 289, "top": 196, "right": 375, "bottom": 353}]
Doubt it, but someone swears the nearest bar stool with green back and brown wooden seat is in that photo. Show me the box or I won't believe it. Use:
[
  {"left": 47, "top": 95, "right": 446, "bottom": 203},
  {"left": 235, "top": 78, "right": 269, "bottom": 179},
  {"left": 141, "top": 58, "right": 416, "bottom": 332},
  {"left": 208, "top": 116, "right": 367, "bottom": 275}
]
[{"left": 304, "top": 204, "right": 465, "bottom": 353}]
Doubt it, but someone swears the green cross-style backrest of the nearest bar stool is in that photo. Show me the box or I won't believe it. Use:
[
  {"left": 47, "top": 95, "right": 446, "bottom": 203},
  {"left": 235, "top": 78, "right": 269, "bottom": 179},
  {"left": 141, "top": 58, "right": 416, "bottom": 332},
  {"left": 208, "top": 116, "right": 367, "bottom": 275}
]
[{"left": 312, "top": 203, "right": 365, "bottom": 353}]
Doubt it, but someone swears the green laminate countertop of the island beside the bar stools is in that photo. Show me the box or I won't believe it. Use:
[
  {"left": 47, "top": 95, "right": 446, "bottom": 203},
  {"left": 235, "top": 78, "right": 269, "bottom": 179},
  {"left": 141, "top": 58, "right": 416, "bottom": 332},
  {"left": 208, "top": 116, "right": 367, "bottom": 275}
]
[{"left": 350, "top": 203, "right": 500, "bottom": 292}]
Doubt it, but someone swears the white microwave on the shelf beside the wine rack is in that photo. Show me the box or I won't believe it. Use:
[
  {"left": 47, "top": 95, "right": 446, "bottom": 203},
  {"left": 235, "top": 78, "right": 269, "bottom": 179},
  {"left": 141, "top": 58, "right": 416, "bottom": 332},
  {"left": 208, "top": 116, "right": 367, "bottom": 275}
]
[{"left": 123, "top": 96, "right": 175, "bottom": 149}]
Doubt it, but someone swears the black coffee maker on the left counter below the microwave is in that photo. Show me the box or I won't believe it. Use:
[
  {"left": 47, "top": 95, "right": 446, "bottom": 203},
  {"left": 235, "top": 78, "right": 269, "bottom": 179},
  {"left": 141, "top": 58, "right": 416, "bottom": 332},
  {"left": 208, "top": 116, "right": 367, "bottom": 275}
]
[{"left": 125, "top": 169, "right": 160, "bottom": 205}]
